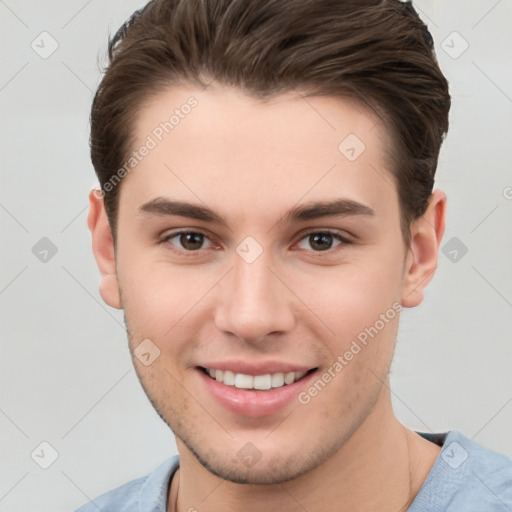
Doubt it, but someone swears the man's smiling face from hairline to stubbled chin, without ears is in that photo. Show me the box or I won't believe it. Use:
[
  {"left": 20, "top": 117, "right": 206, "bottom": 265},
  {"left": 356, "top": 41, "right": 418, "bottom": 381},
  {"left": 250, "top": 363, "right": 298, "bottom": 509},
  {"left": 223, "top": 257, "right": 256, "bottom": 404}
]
[{"left": 96, "top": 84, "right": 416, "bottom": 483}]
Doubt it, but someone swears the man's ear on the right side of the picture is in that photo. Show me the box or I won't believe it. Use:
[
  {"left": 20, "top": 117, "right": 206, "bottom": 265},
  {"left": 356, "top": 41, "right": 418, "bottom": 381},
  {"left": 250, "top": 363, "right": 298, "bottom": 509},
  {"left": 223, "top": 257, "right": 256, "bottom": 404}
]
[{"left": 402, "top": 190, "right": 446, "bottom": 308}]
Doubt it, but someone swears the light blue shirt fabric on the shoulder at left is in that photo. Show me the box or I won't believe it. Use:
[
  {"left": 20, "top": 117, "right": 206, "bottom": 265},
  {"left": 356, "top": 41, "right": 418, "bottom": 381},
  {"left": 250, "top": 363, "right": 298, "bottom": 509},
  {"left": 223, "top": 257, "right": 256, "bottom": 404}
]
[{"left": 75, "top": 455, "right": 179, "bottom": 512}]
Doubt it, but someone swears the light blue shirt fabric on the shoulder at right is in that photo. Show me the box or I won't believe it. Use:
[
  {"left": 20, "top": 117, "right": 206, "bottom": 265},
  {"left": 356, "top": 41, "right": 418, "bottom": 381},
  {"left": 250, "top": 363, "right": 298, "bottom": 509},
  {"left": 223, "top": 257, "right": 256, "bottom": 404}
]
[{"left": 410, "top": 430, "right": 512, "bottom": 512}]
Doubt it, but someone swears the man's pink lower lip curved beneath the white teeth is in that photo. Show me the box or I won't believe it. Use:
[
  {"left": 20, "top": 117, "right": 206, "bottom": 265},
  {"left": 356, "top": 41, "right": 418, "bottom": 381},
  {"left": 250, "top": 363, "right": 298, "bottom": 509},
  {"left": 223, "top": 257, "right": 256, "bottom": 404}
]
[{"left": 196, "top": 368, "right": 316, "bottom": 418}]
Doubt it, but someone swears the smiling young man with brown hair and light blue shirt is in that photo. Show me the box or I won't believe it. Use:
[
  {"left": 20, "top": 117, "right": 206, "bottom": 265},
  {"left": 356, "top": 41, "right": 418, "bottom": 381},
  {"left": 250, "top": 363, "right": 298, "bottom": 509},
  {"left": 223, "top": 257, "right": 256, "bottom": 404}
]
[{"left": 74, "top": 0, "right": 512, "bottom": 512}]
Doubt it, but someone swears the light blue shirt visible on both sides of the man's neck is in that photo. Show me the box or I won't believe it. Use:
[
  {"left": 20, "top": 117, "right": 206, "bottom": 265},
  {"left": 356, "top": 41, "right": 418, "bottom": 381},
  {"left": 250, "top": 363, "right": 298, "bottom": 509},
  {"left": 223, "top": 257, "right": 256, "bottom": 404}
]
[{"left": 75, "top": 430, "right": 512, "bottom": 512}]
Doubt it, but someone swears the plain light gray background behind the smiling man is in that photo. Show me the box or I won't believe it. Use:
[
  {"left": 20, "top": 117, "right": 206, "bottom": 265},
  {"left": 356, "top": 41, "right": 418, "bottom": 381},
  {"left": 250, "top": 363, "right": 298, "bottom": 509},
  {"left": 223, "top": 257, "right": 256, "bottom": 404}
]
[{"left": 0, "top": 0, "right": 512, "bottom": 512}]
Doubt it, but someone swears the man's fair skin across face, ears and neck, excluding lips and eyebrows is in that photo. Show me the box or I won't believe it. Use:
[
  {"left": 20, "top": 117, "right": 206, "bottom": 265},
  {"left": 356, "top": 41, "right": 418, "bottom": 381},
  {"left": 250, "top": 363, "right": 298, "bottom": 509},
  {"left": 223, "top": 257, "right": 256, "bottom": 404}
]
[{"left": 88, "top": 86, "right": 446, "bottom": 512}]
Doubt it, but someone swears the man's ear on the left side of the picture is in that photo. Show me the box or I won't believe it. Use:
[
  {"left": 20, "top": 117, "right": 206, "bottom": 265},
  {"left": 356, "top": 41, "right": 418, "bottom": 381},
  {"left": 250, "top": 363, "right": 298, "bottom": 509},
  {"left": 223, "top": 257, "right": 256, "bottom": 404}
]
[{"left": 87, "top": 189, "right": 122, "bottom": 309}]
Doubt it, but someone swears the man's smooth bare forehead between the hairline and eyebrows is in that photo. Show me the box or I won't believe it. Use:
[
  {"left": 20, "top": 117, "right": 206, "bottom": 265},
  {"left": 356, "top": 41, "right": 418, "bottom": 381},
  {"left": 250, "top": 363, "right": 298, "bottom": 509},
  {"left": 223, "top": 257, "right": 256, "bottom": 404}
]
[{"left": 121, "top": 86, "right": 398, "bottom": 226}]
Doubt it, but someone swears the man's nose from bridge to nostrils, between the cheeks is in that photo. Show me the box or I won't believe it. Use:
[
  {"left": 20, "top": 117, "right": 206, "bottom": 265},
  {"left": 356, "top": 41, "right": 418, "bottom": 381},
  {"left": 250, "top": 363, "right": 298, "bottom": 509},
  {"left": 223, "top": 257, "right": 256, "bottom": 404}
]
[{"left": 215, "top": 245, "right": 296, "bottom": 343}]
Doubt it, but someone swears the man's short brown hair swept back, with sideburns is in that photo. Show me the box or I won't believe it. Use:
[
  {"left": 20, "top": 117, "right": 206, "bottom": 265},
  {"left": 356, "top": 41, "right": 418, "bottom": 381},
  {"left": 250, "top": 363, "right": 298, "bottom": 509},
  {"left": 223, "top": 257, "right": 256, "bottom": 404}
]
[{"left": 90, "top": 0, "right": 451, "bottom": 245}]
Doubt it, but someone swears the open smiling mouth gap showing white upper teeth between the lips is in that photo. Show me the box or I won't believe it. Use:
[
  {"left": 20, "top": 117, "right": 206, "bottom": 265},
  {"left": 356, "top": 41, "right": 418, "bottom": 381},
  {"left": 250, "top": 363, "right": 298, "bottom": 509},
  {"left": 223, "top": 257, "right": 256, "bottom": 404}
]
[{"left": 199, "top": 366, "right": 318, "bottom": 391}]
